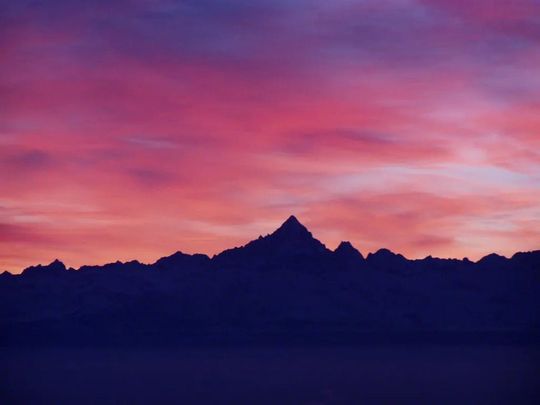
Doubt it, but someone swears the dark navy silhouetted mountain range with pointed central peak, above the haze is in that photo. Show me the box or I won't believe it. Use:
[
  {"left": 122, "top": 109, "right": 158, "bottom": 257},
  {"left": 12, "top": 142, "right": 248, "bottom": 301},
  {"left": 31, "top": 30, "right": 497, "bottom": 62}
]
[{"left": 0, "top": 217, "right": 540, "bottom": 345}]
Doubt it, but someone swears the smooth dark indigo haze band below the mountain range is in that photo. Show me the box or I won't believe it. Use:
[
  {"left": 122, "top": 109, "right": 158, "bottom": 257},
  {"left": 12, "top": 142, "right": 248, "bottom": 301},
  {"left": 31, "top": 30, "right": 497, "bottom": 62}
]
[{"left": 0, "top": 344, "right": 540, "bottom": 404}]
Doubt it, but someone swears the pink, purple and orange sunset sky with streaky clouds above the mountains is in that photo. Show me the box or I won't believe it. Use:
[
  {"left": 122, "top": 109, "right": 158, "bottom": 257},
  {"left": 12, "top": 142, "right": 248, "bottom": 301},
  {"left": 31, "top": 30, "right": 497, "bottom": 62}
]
[{"left": 0, "top": 0, "right": 540, "bottom": 273}]
